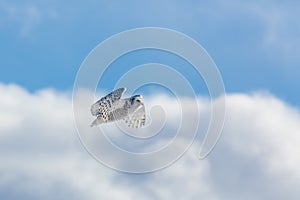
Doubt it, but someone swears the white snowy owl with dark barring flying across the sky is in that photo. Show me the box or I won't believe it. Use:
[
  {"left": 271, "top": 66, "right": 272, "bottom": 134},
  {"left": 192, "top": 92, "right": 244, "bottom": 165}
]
[{"left": 91, "top": 88, "right": 146, "bottom": 128}]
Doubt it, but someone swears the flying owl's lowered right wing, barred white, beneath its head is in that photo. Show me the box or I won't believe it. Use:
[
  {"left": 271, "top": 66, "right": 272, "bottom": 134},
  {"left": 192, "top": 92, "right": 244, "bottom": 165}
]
[{"left": 124, "top": 103, "right": 146, "bottom": 128}]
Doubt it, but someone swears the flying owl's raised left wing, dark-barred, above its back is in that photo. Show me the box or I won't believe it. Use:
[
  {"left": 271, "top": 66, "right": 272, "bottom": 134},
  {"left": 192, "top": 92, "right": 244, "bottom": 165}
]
[{"left": 91, "top": 88, "right": 126, "bottom": 119}]
